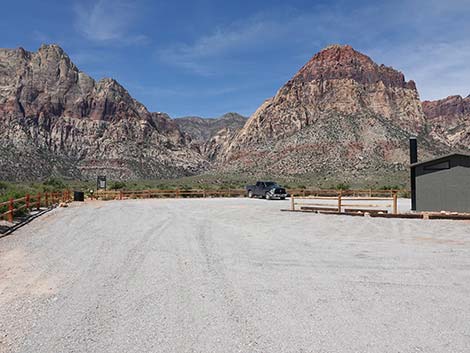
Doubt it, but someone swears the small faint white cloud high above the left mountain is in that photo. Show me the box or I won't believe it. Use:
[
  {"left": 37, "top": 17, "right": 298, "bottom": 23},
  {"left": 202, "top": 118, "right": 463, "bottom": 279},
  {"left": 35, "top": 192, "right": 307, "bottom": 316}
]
[{"left": 74, "top": 0, "right": 149, "bottom": 45}]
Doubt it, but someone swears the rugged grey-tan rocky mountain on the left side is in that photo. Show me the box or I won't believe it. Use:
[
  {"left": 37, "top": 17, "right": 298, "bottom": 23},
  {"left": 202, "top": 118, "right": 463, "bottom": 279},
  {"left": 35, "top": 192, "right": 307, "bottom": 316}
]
[{"left": 0, "top": 45, "right": 207, "bottom": 180}]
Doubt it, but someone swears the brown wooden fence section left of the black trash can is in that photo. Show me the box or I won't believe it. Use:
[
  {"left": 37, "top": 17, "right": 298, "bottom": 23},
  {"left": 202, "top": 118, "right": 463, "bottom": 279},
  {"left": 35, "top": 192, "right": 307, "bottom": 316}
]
[{"left": 0, "top": 190, "right": 71, "bottom": 223}]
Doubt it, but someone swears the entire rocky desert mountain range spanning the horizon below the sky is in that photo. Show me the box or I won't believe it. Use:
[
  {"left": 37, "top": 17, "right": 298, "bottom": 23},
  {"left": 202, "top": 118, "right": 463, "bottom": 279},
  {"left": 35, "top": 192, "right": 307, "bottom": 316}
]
[{"left": 0, "top": 45, "right": 470, "bottom": 185}]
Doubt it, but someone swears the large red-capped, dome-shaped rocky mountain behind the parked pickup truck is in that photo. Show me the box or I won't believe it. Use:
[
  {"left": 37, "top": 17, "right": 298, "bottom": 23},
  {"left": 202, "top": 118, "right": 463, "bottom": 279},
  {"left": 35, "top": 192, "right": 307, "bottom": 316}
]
[{"left": 219, "top": 45, "right": 439, "bottom": 180}]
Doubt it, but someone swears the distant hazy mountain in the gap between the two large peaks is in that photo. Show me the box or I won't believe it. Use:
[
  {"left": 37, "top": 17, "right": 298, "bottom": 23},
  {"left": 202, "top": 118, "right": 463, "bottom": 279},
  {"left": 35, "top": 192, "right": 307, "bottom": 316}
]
[{"left": 174, "top": 113, "right": 248, "bottom": 162}]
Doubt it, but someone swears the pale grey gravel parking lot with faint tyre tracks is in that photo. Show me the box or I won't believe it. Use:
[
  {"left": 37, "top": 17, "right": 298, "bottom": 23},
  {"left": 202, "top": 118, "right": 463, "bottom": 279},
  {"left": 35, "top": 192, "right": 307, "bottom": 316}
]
[{"left": 0, "top": 199, "right": 470, "bottom": 353}]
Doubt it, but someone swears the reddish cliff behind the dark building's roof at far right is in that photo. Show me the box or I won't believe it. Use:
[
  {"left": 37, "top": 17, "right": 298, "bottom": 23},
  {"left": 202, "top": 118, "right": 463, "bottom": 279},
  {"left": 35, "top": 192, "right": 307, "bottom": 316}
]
[{"left": 423, "top": 96, "right": 470, "bottom": 148}]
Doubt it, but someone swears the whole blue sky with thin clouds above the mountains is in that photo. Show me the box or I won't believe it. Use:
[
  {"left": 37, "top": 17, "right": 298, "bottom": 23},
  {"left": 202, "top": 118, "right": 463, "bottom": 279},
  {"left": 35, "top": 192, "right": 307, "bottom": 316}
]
[{"left": 0, "top": 0, "right": 470, "bottom": 117}]
